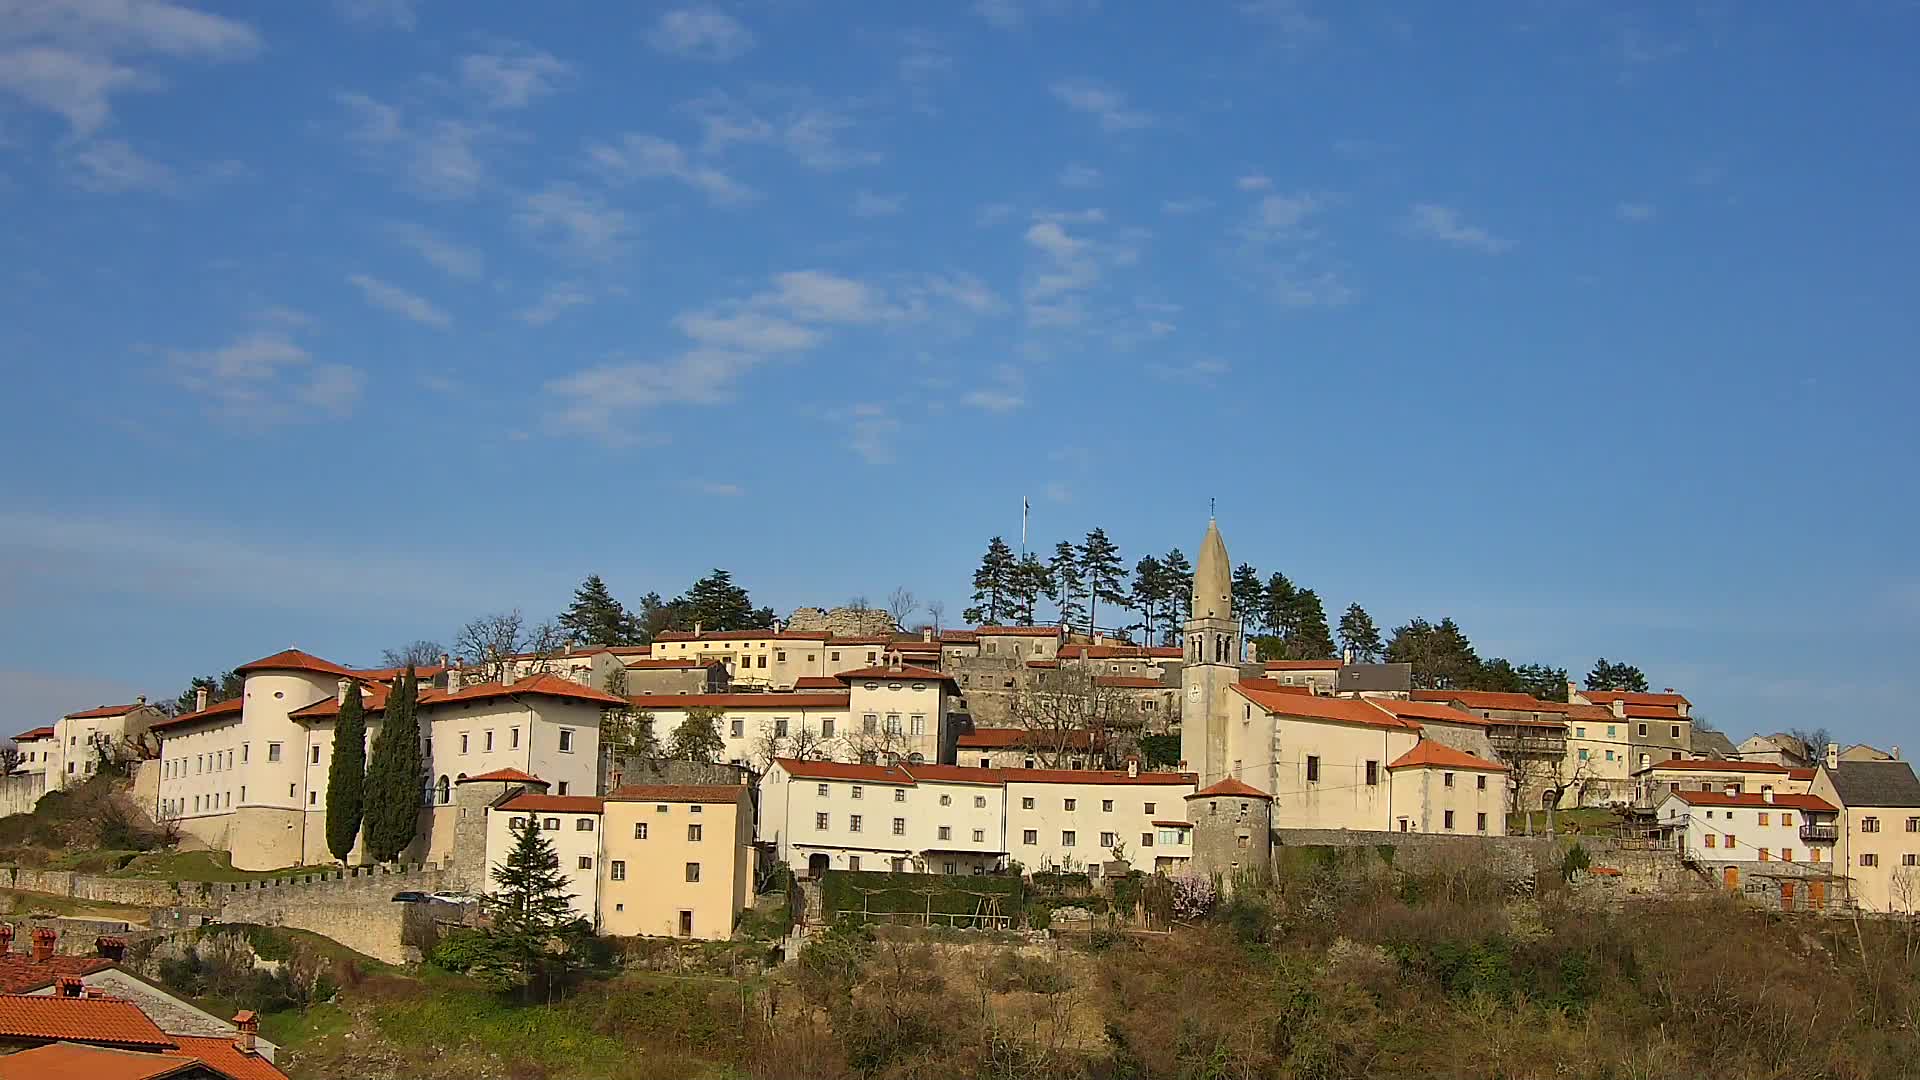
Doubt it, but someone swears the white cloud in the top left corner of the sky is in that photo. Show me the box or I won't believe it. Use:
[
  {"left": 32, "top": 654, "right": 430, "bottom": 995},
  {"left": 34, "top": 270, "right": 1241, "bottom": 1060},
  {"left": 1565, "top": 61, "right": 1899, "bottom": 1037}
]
[{"left": 0, "top": 0, "right": 261, "bottom": 136}]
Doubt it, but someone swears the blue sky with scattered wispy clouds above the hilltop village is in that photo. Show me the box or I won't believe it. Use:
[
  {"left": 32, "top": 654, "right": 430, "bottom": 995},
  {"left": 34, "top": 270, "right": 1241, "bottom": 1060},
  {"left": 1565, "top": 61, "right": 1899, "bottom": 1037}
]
[{"left": 0, "top": 0, "right": 1920, "bottom": 744}]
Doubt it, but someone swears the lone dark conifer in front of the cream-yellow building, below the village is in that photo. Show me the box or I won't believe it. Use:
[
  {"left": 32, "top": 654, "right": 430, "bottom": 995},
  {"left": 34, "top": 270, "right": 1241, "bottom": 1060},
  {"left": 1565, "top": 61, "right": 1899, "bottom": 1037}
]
[{"left": 474, "top": 815, "right": 588, "bottom": 990}]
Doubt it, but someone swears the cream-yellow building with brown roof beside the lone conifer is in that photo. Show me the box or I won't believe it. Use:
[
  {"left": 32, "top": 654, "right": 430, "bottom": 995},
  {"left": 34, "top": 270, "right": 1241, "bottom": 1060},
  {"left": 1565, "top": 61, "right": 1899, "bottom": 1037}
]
[{"left": 599, "top": 784, "right": 755, "bottom": 940}]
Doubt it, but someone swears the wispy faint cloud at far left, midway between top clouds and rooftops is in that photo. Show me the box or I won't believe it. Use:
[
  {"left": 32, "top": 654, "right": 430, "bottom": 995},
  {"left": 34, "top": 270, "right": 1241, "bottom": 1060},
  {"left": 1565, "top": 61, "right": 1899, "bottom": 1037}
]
[{"left": 167, "top": 329, "right": 367, "bottom": 427}]
